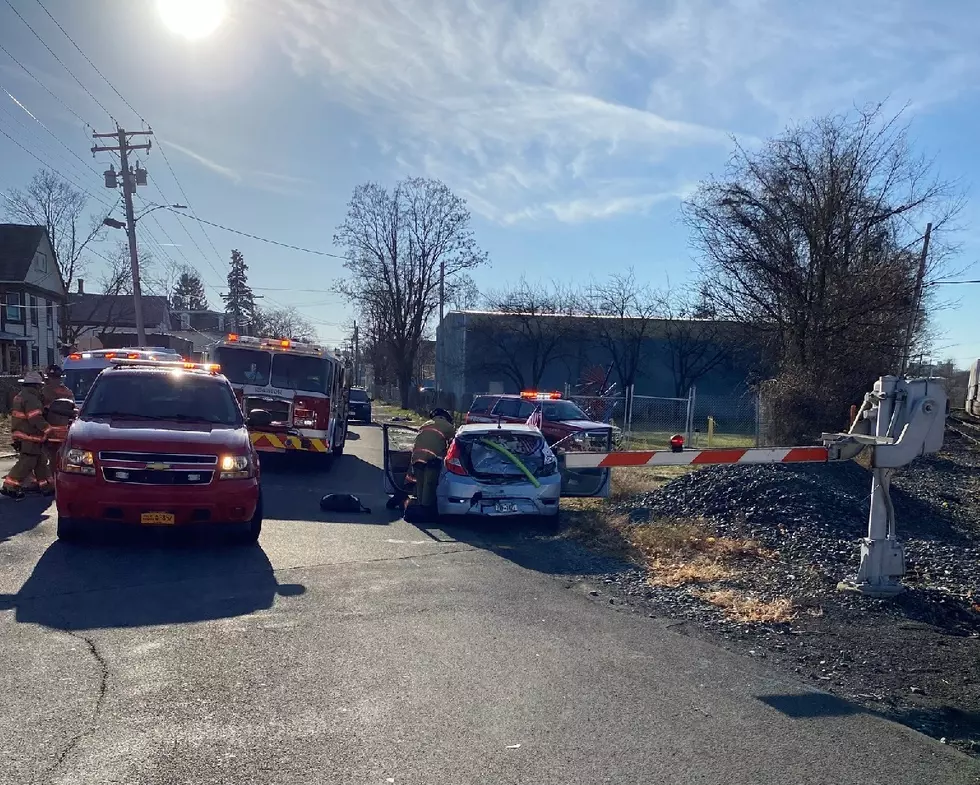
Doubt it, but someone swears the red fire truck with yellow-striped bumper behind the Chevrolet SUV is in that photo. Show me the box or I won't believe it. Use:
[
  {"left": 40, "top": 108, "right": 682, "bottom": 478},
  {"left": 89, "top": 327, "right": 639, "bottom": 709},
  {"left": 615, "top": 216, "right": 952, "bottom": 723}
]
[{"left": 207, "top": 334, "right": 352, "bottom": 455}]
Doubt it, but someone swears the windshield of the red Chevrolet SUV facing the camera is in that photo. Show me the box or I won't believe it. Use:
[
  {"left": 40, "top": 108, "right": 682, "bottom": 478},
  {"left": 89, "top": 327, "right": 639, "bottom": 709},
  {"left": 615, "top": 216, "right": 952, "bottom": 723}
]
[{"left": 79, "top": 371, "right": 242, "bottom": 427}]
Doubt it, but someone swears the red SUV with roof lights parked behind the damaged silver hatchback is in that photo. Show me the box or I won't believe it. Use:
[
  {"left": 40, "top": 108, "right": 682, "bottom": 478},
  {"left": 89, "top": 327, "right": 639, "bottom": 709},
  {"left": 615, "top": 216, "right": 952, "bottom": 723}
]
[{"left": 465, "top": 392, "right": 617, "bottom": 451}]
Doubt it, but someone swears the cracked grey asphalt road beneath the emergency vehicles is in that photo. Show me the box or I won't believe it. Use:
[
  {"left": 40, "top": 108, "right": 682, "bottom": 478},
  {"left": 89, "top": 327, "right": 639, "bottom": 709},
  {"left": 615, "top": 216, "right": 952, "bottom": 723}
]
[{"left": 0, "top": 426, "right": 980, "bottom": 785}]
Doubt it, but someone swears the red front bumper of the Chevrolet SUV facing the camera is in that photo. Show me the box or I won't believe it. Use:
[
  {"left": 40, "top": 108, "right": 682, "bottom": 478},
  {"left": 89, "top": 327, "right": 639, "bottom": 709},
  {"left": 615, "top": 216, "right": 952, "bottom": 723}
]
[{"left": 55, "top": 472, "right": 260, "bottom": 526}]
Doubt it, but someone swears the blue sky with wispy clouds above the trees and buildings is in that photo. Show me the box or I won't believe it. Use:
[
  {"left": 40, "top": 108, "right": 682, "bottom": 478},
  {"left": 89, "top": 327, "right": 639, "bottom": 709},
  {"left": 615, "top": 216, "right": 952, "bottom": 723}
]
[{"left": 0, "top": 0, "right": 980, "bottom": 364}]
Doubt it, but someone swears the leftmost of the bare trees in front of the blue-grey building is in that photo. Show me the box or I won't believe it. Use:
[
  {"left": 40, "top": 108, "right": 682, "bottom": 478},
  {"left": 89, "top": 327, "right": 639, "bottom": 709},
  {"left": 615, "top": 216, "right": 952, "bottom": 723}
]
[{"left": 467, "top": 278, "right": 578, "bottom": 390}]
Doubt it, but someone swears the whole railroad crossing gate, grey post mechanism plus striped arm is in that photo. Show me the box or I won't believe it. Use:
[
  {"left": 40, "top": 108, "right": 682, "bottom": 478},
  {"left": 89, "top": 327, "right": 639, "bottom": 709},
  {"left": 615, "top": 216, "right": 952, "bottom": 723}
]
[{"left": 565, "top": 376, "right": 948, "bottom": 597}]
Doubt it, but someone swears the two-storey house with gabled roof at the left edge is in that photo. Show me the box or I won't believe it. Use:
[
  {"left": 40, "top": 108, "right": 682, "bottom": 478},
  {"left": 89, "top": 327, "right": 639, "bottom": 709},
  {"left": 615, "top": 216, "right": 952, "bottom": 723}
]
[{"left": 0, "top": 224, "right": 66, "bottom": 375}]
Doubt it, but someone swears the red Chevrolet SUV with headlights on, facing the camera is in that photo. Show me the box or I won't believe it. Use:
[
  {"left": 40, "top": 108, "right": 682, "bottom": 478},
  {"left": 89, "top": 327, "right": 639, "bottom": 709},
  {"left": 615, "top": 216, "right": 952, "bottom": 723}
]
[{"left": 55, "top": 361, "right": 262, "bottom": 543}]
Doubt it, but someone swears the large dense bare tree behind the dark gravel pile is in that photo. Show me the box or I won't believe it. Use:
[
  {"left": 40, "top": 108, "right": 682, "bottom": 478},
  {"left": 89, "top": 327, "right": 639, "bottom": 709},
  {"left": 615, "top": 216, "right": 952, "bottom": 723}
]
[{"left": 685, "top": 101, "right": 962, "bottom": 438}]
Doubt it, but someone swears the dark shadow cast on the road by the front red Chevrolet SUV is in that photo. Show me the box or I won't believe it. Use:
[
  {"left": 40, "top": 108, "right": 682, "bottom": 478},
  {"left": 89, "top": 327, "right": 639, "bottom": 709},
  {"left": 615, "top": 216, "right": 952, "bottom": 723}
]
[{"left": 0, "top": 531, "right": 306, "bottom": 630}]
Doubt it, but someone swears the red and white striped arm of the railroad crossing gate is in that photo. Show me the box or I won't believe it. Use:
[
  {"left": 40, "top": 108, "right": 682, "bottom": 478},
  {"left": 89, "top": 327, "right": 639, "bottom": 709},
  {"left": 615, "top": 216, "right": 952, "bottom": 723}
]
[{"left": 565, "top": 447, "right": 829, "bottom": 469}]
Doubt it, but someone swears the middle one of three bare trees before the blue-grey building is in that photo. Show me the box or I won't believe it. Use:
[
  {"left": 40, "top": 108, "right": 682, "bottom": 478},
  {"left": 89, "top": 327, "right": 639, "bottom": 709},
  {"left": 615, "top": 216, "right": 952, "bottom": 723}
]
[{"left": 582, "top": 267, "right": 663, "bottom": 391}]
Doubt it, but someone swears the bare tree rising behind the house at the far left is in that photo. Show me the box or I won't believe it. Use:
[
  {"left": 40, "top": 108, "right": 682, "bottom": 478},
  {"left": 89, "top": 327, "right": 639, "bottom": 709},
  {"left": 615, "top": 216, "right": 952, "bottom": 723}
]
[{"left": 5, "top": 169, "right": 102, "bottom": 291}]
